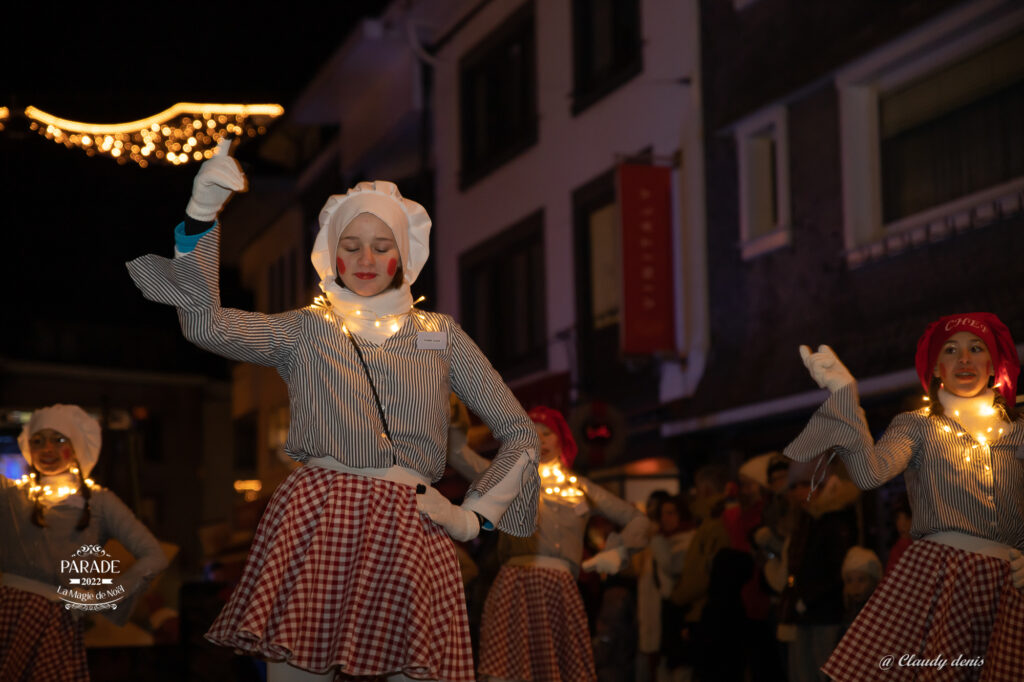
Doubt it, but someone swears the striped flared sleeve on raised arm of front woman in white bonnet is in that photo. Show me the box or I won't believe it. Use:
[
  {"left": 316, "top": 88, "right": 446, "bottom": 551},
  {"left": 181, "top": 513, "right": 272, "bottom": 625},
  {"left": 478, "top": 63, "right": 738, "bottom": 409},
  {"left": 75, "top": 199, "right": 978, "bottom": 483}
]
[{"left": 127, "top": 225, "right": 302, "bottom": 368}]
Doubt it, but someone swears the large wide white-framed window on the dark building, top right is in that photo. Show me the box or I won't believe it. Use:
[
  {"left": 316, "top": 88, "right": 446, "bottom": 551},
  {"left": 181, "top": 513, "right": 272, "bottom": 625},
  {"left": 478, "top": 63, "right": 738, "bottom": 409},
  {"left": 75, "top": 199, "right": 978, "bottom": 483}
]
[{"left": 837, "top": 3, "right": 1024, "bottom": 267}]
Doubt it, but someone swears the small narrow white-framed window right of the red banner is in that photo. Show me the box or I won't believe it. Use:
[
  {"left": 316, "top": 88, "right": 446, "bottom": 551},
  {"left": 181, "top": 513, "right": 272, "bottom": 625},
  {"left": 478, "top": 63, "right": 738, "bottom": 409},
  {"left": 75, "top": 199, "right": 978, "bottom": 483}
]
[{"left": 735, "top": 105, "right": 790, "bottom": 259}]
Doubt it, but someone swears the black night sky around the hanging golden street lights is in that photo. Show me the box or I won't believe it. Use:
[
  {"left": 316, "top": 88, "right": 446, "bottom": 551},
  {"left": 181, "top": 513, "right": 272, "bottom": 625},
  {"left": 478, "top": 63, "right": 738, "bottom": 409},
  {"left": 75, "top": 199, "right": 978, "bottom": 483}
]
[{"left": 0, "top": 0, "right": 386, "bottom": 365}]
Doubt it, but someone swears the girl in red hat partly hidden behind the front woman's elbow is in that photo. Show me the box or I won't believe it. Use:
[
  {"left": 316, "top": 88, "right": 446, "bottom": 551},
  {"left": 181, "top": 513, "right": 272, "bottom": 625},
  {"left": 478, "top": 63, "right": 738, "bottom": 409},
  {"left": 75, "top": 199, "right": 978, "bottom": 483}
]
[{"left": 449, "top": 407, "right": 650, "bottom": 682}]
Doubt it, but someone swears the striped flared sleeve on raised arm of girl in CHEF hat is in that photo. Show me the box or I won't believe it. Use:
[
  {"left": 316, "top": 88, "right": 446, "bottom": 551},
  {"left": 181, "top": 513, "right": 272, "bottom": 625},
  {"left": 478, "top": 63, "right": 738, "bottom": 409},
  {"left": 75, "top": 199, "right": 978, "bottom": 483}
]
[{"left": 782, "top": 382, "right": 921, "bottom": 491}]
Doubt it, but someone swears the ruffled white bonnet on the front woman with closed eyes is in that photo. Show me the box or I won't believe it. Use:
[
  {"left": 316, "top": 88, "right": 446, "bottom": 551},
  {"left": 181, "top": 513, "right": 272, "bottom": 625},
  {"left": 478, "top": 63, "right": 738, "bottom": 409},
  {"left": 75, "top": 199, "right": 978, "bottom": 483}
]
[{"left": 310, "top": 180, "right": 430, "bottom": 293}]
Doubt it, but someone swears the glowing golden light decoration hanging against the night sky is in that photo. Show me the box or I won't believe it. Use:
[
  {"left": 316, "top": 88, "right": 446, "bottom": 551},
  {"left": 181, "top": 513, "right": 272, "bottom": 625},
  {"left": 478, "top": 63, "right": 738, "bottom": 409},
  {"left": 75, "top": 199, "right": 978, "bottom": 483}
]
[{"left": 25, "top": 102, "right": 285, "bottom": 168}]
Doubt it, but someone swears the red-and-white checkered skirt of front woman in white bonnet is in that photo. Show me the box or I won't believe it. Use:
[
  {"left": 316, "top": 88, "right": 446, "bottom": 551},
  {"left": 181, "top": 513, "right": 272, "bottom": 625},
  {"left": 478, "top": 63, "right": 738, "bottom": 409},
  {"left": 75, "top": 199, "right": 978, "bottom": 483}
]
[{"left": 206, "top": 466, "right": 473, "bottom": 682}]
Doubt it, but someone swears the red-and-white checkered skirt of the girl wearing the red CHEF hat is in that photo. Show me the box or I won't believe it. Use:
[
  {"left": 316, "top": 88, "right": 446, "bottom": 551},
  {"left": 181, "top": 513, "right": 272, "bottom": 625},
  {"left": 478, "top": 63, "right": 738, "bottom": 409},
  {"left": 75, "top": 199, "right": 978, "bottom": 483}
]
[{"left": 821, "top": 540, "right": 1024, "bottom": 682}]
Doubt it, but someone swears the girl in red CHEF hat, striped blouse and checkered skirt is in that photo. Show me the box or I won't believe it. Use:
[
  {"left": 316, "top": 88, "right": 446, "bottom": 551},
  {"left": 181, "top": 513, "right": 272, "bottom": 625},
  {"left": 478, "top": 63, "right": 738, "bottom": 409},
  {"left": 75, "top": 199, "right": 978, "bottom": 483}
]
[{"left": 785, "top": 312, "right": 1024, "bottom": 682}]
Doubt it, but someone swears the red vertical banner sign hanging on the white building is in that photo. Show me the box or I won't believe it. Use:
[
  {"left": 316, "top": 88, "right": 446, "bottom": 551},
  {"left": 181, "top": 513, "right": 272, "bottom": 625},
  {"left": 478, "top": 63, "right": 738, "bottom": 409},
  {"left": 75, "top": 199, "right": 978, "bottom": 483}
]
[{"left": 616, "top": 164, "right": 676, "bottom": 354}]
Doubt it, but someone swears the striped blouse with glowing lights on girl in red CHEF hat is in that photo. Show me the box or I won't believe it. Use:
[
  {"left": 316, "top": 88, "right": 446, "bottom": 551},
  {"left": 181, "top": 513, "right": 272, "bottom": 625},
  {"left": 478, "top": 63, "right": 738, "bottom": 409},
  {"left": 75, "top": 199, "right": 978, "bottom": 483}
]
[{"left": 783, "top": 383, "right": 1024, "bottom": 548}]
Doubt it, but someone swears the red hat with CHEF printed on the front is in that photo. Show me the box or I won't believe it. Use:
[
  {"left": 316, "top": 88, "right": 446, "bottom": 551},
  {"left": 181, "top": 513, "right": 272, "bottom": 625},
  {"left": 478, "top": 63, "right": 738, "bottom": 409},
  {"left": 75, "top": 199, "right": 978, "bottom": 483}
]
[{"left": 913, "top": 312, "right": 1021, "bottom": 406}]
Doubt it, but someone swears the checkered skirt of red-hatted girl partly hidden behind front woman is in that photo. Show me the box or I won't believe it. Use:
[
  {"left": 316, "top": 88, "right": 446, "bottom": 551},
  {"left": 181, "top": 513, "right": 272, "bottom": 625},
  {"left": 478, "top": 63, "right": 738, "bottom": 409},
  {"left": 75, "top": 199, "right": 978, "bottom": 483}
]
[{"left": 480, "top": 565, "right": 597, "bottom": 682}]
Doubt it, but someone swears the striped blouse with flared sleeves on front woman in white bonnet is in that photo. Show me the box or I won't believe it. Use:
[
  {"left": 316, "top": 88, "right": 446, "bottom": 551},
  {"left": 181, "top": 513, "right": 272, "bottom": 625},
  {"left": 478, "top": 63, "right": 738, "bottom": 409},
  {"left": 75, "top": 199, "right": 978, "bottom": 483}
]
[{"left": 128, "top": 226, "right": 540, "bottom": 536}]
